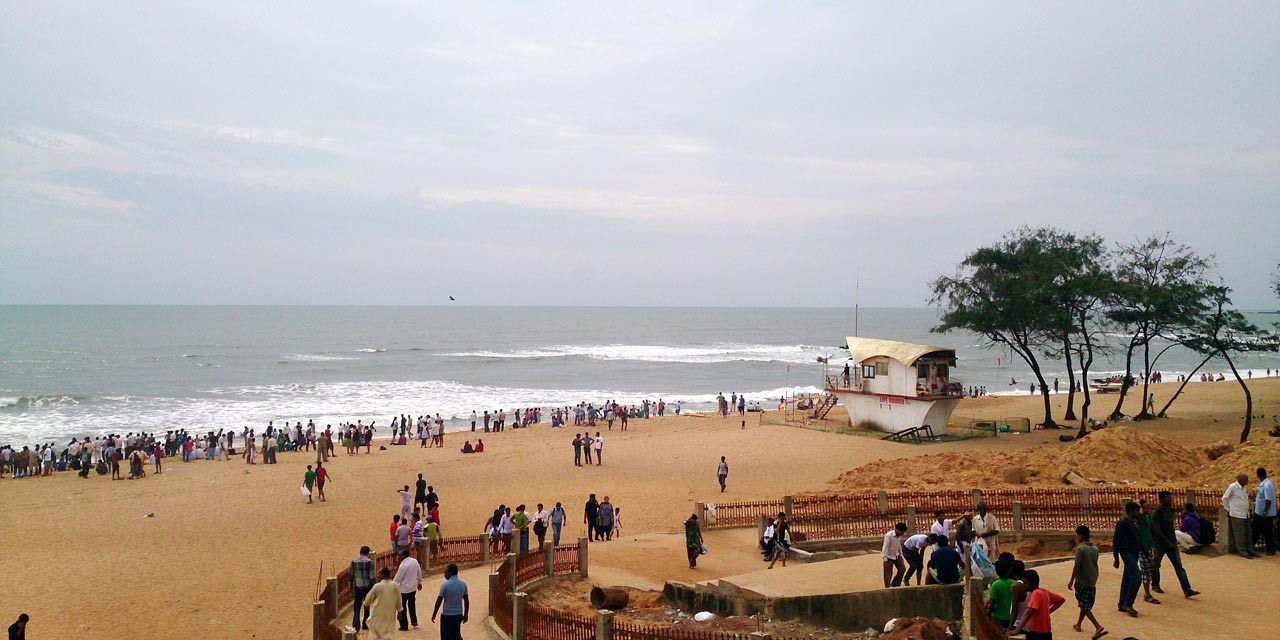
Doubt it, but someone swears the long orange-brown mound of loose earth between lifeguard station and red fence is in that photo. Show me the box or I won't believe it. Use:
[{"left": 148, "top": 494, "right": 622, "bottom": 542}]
[{"left": 820, "top": 426, "right": 1208, "bottom": 493}]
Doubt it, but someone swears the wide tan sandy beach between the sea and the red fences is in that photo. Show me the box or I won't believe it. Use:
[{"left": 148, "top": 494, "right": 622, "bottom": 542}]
[{"left": 0, "top": 379, "right": 1280, "bottom": 639}]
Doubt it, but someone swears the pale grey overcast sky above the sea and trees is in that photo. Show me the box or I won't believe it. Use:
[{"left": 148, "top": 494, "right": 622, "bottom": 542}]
[{"left": 0, "top": 0, "right": 1280, "bottom": 308}]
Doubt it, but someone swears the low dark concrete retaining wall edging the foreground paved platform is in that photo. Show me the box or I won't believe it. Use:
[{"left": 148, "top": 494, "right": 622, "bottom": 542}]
[{"left": 663, "top": 582, "right": 964, "bottom": 631}]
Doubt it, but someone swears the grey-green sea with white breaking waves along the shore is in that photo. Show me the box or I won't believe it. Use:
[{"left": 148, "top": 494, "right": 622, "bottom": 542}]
[{"left": 0, "top": 306, "right": 1280, "bottom": 444}]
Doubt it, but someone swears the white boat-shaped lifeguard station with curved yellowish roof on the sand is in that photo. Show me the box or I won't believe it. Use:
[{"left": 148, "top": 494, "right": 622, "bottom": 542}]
[{"left": 826, "top": 338, "right": 964, "bottom": 435}]
